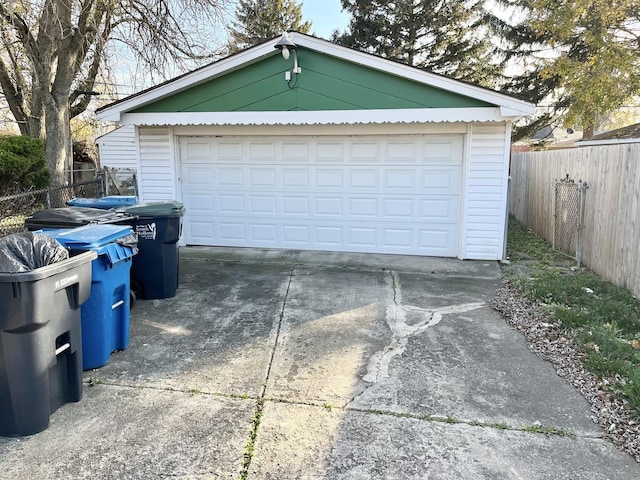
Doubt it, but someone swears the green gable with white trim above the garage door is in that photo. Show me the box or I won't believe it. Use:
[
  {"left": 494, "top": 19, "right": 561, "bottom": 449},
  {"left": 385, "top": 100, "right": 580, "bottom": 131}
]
[{"left": 97, "top": 32, "right": 535, "bottom": 125}]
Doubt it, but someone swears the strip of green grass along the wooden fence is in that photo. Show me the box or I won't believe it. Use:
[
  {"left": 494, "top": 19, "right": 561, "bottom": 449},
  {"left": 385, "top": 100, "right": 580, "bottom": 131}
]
[{"left": 504, "top": 218, "right": 640, "bottom": 419}]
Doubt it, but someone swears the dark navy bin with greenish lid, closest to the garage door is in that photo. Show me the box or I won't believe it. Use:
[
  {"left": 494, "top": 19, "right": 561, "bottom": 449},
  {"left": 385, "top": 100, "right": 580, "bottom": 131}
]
[{"left": 118, "top": 201, "right": 185, "bottom": 299}]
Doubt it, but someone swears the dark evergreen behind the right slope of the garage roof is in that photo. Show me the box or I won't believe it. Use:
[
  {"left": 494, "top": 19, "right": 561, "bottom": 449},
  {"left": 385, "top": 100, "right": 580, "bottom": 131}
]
[{"left": 333, "top": 0, "right": 501, "bottom": 86}]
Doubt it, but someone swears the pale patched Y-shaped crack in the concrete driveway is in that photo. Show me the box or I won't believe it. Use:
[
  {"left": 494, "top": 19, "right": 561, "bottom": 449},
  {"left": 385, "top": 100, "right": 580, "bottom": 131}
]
[{"left": 362, "top": 271, "right": 485, "bottom": 384}]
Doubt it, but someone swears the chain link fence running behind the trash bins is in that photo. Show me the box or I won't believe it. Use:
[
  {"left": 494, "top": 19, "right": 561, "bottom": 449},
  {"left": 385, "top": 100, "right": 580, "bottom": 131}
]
[{"left": 0, "top": 176, "right": 105, "bottom": 237}]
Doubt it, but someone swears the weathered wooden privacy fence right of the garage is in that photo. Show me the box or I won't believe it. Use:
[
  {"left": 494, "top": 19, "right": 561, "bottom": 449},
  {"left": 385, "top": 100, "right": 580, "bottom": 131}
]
[{"left": 509, "top": 143, "right": 640, "bottom": 297}]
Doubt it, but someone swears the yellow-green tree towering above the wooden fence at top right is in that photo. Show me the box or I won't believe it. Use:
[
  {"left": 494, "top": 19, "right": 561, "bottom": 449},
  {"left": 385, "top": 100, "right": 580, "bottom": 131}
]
[{"left": 494, "top": 0, "right": 640, "bottom": 137}]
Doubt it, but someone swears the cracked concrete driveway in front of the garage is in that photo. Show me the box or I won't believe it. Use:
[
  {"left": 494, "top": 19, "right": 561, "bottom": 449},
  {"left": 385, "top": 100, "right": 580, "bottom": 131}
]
[{"left": 0, "top": 248, "right": 640, "bottom": 480}]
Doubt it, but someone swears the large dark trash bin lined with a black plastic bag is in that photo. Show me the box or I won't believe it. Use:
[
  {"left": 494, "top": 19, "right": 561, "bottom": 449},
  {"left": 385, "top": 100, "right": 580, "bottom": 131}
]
[{"left": 0, "top": 236, "right": 97, "bottom": 436}]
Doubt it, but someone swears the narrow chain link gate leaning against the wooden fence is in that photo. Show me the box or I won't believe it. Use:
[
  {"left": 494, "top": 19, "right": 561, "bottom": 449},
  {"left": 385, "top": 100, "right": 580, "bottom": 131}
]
[{"left": 553, "top": 173, "right": 588, "bottom": 268}]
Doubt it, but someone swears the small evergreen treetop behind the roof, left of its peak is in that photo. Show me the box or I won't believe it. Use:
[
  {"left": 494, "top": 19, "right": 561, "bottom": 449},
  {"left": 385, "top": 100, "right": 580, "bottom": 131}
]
[{"left": 229, "top": 0, "right": 311, "bottom": 53}]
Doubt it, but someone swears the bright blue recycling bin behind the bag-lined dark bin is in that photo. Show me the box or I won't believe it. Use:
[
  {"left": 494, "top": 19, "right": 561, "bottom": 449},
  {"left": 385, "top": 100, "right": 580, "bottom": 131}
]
[{"left": 42, "top": 225, "right": 138, "bottom": 370}]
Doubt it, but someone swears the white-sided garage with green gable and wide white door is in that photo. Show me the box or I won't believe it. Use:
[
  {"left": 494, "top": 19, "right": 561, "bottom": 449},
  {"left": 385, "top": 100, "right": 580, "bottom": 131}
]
[{"left": 97, "top": 32, "right": 534, "bottom": 260}]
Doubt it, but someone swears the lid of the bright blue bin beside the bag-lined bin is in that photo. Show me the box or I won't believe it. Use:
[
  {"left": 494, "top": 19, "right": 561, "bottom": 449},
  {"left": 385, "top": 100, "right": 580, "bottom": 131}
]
[{"left": 40, "top": 224, "right": 138, "bottom": 264}]
